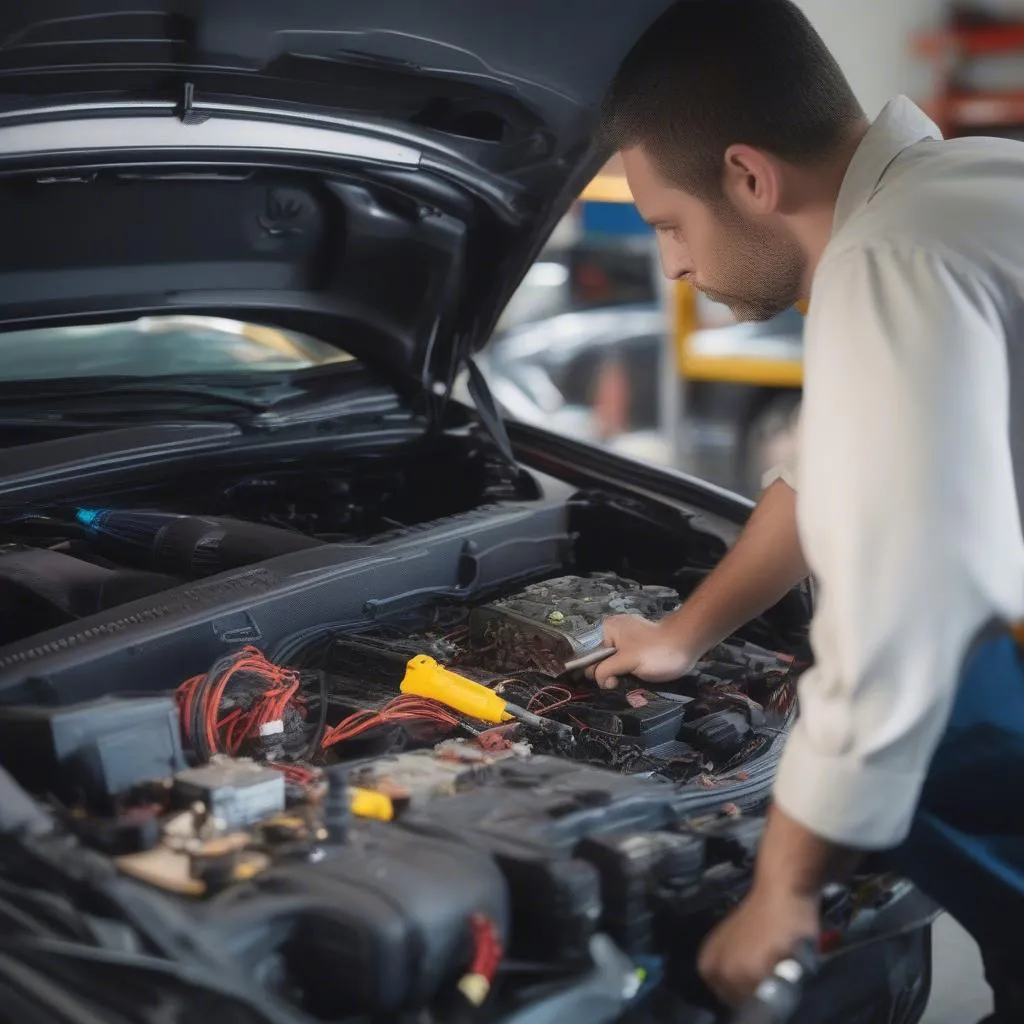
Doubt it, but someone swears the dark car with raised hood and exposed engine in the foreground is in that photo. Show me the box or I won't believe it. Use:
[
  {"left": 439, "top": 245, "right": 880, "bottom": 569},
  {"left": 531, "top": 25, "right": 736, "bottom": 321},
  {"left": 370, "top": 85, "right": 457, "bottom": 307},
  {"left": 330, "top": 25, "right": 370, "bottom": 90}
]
[{"left": 0, "top": 0, "right": 936, "bottom": 1024}]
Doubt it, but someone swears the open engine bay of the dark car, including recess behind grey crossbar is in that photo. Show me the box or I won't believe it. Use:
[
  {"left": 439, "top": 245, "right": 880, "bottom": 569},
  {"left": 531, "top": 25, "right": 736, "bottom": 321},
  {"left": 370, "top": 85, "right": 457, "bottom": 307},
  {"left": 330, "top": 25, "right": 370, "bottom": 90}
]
[{"left": 0, "top": 446, "right": 929, "bottom": 1024}]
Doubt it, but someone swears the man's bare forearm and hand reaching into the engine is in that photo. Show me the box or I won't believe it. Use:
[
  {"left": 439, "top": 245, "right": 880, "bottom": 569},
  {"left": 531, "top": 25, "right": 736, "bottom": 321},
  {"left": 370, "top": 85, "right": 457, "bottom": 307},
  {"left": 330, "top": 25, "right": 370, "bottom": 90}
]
[{"left": 593, "top": 478, "right": 807, "bottom": 687}]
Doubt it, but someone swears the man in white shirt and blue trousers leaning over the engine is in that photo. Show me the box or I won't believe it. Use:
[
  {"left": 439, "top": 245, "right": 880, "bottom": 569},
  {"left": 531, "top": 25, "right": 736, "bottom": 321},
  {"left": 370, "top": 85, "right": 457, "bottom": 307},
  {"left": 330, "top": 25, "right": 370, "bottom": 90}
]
[{"left": 591, "top": 0, "right": 1024, "bottom": 1022}]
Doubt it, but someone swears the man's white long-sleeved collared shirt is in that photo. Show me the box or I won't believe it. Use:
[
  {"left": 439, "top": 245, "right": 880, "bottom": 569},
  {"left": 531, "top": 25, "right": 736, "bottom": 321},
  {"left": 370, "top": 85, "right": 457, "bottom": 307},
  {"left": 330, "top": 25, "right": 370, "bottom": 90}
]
[{"left": 775, "top": 97, "right": 1024, "bottom": 849}]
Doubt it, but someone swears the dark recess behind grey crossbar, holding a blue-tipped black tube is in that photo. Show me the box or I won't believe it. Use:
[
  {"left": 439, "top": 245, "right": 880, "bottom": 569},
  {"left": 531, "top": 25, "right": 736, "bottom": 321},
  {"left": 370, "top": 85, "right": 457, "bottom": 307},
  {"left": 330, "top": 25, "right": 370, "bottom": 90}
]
[{"left": 0, "top": 438, "right": 536, "bottom": 645}]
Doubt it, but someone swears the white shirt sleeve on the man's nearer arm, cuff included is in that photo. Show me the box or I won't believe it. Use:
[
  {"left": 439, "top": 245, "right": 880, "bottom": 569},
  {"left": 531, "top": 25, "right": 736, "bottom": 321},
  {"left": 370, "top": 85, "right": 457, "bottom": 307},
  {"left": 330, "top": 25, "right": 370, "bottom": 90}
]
[{"left": 775, "top": 245, "right": 1024, "bottom": 850}]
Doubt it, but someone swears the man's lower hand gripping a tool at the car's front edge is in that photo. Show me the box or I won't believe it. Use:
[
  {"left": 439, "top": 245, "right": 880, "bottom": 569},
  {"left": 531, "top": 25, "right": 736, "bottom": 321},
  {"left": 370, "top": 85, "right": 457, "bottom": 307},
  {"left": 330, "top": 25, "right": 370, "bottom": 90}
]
[{"left": 697, "top": 883, "right": 820, "bottom": 1008}]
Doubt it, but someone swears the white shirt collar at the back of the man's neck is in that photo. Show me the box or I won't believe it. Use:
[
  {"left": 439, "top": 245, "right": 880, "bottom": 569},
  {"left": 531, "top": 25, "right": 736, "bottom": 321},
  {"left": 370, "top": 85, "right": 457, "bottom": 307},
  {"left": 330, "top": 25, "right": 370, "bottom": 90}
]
[{"left": 833, "top": 96, "right": 942, "bottom": 237}]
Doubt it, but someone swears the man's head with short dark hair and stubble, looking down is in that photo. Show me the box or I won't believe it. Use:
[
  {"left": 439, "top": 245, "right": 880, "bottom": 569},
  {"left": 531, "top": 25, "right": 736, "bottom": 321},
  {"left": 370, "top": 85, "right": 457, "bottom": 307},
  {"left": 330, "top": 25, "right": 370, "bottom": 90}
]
[{"left": 602, "top": 0, "right": 864, "bottom": 319}]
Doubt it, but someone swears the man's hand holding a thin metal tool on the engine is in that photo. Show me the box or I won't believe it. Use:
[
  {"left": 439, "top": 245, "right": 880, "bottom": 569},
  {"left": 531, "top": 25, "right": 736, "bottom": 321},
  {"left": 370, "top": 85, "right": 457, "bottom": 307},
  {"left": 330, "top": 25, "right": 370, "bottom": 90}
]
[{"left": 587, "top": 615, "right": 703, "bottom": 689}]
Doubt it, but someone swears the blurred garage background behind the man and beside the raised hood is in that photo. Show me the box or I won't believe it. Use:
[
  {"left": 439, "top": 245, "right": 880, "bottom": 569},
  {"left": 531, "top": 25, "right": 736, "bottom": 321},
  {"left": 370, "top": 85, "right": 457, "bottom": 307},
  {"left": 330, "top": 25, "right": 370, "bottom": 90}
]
[{"left": 481, "top": 0, "right": 1024, "bottom": 498}]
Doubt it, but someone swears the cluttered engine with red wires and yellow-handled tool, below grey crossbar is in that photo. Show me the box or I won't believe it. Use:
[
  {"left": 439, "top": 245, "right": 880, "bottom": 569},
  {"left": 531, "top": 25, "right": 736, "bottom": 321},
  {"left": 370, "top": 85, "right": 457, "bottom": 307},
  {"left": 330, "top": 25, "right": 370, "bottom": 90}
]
[{"left": 0, "top": 569, "right": 864, "bottom": 1020}]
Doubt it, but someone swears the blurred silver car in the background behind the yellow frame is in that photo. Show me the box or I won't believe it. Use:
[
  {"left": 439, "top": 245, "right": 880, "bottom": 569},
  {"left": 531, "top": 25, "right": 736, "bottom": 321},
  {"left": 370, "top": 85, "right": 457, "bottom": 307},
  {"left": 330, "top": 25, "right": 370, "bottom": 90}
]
[{"left": 478, "top": 303, "right": 803, "bottom": 498}]
